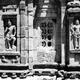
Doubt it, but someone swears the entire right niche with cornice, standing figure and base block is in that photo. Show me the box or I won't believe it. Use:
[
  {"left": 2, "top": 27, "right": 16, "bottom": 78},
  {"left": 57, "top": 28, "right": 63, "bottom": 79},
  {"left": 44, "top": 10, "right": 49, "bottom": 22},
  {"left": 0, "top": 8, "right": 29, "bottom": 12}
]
[{"left": 66, "top": 0, "right": 80, "bottom": 66}]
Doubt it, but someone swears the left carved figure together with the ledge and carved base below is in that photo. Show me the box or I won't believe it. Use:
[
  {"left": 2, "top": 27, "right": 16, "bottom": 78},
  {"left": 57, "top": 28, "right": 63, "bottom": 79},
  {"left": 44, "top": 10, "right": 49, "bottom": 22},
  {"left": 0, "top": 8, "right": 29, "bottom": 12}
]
[{"left": 0, "top": 19, "right": 20, "bottom": 64}]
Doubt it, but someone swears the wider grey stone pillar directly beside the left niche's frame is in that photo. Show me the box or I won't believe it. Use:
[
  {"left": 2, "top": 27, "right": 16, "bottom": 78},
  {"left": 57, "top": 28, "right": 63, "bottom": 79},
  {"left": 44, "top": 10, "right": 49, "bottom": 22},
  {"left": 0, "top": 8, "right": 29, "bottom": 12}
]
[{"left": 20, "top": 0, "right": 28, "bottom": 64}]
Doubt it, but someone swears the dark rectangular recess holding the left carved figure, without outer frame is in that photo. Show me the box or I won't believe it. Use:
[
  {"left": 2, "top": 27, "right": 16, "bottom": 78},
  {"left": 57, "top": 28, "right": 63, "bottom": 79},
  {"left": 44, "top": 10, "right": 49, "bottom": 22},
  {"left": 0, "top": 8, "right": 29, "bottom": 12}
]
[{"left": 2, "top": 14, "right": 17, "bottom": 51}]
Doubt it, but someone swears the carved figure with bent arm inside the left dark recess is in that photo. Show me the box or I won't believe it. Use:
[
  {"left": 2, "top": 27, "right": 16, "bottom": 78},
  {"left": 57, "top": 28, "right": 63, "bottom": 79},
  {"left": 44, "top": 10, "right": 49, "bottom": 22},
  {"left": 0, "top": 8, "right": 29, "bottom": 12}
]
[{"left": 5, "top": 20, "right": 16, "bottom": 49}]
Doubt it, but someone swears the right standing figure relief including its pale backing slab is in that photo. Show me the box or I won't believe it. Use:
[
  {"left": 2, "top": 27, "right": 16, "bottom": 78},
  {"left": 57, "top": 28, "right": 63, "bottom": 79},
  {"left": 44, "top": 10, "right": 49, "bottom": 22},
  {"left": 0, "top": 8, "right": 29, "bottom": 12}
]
[{"left": 70, "top": 19, "right": 80, "bottom": 50}]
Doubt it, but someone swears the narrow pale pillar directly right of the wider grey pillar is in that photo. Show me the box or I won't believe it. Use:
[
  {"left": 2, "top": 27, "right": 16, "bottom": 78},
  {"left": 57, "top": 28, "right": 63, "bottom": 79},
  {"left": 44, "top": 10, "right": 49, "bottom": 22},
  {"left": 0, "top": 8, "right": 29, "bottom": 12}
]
[{"left": 28, "top": 2, "right": 35, "bottom": 69}]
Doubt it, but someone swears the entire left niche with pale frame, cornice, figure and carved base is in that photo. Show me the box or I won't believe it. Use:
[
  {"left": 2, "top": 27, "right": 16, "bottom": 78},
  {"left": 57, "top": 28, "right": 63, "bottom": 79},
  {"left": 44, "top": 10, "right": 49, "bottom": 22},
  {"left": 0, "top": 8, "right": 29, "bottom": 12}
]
[{"left": 0, "top": 5, "right": 20, "bottom": 64}]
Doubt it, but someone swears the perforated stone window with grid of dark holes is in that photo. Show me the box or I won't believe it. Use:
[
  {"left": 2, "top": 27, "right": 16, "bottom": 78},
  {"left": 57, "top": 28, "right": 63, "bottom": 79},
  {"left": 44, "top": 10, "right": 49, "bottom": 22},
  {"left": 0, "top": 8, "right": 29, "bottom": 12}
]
[{"left": 40, "top": 22, "right": 54, "bottom": 47}]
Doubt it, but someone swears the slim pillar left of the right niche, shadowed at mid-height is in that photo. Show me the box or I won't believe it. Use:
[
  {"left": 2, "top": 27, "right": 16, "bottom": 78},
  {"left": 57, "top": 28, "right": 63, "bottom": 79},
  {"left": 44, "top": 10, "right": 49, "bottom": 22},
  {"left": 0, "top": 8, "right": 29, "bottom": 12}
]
[{"left": 61, "top": 6, "right": 66, "bottom": 65}]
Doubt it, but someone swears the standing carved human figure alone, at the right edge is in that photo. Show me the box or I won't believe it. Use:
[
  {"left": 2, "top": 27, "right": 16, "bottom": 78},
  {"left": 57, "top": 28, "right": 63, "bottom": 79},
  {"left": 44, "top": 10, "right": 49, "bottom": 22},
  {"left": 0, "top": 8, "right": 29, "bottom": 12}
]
[{"left": 71, "top": 19, "right": 80, "bottom": 49}]
